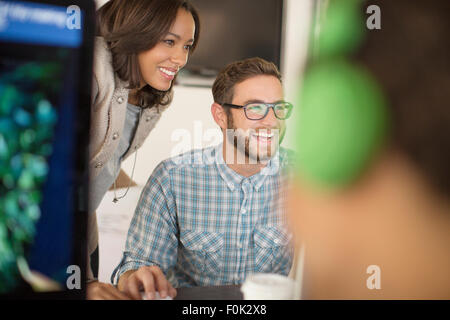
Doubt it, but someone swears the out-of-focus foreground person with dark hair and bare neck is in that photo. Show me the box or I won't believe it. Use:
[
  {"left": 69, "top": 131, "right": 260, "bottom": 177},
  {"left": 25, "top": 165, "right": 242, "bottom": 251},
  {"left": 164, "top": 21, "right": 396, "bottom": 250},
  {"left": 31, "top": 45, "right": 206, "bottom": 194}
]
[{"left": 290, "top": 0, "right": 450, "bottom": 299}]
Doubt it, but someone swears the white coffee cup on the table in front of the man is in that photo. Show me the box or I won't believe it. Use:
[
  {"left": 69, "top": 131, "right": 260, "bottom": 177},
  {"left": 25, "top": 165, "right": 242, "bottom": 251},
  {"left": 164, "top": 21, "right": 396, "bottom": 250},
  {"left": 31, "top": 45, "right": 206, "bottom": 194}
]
[{"left": 241, "top": 273, "right": 295, "bottom": 300}]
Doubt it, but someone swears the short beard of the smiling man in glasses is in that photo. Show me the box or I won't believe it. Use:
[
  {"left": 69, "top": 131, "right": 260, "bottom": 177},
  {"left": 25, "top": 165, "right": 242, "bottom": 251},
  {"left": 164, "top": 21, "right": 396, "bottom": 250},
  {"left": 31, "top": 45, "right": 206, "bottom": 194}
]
[{"left": 226, "top": 114, "right": 285, "bottom": 164}]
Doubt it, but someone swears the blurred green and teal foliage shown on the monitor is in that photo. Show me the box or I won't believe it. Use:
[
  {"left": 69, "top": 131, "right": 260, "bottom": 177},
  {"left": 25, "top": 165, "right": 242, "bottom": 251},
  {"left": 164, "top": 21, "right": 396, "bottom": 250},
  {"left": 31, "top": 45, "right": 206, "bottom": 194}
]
[{"left": 0, "top": 62, "right": 61, "bottom": 292}]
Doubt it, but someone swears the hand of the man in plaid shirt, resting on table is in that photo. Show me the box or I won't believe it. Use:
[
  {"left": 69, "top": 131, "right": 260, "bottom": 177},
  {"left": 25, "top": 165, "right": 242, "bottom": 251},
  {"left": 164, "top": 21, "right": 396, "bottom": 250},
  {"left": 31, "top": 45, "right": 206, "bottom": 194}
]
[{"left": 119, "top": 266, "right": 177, "bottom": 300}]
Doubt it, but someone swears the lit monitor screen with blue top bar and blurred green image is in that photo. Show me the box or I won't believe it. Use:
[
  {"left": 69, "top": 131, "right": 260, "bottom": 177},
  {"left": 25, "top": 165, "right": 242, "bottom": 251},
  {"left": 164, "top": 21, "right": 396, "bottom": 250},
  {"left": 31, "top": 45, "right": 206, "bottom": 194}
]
[{"left": 0, "top": 1, "right": 94, "bottom": 294}]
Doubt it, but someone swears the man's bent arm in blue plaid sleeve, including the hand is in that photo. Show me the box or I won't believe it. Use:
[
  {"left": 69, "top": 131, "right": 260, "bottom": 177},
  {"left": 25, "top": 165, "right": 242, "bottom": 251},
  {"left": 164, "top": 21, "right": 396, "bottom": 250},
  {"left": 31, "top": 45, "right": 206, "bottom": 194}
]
[{"left": 112, "top": 162, "right": 178, "bottom": 299}]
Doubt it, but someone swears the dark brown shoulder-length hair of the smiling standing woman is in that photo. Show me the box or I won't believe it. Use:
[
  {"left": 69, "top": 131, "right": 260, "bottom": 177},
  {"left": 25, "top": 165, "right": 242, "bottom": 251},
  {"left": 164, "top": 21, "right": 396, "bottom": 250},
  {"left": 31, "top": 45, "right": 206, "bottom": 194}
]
[{"left": 97, "top": 0, "right": 200, "bottom": 108}]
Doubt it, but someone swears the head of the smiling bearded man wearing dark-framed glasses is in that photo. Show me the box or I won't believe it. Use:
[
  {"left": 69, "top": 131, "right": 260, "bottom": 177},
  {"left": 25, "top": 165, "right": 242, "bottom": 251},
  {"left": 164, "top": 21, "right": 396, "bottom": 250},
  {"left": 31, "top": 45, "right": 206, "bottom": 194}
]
[{"left": 211, "top": 58, "right": 292, "bottom": 163}]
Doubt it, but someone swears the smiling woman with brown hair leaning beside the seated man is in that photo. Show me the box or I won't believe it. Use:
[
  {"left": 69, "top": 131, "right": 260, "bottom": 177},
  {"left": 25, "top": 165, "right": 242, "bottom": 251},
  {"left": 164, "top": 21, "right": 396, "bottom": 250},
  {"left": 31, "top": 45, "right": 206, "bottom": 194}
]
[{"left": 88, "top": 0, "right": 199, "bottom": 299}]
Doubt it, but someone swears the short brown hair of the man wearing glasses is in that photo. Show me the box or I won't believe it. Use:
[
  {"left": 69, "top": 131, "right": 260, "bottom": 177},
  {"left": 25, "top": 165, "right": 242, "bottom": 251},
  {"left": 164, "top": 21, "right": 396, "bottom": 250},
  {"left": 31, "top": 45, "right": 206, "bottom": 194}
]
[{"left": 212, "top": 57, "right": 281, "bottom": 104}]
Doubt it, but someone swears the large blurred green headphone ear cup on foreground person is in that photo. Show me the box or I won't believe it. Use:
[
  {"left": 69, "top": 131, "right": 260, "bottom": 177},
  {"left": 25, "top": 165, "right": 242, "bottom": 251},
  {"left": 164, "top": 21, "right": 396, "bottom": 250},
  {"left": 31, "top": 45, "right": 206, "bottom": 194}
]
[{"left": 296, "top": 60, "right": 387, "bottom": 187}]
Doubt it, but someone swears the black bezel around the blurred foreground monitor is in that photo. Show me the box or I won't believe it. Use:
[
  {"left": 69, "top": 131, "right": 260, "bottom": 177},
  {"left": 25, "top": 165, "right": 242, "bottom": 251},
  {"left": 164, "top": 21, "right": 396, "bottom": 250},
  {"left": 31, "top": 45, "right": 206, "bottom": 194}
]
[{"left": 0, "top": 0, "right": 96, "bottom": 300}]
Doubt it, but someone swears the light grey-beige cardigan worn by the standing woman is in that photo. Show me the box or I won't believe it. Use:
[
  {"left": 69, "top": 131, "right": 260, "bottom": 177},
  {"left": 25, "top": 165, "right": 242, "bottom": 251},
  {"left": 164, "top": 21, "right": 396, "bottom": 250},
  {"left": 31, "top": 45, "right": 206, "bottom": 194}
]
[{"left": 87, "top": 37, "right": 168, "bottom": 281}]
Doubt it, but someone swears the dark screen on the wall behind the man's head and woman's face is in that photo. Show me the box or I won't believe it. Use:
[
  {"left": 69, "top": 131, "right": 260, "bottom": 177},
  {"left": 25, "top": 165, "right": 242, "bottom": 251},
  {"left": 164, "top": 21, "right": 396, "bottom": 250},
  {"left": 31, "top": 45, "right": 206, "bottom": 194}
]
[{"left": 185, "top": 0, "right": 283, "bottom": 75}]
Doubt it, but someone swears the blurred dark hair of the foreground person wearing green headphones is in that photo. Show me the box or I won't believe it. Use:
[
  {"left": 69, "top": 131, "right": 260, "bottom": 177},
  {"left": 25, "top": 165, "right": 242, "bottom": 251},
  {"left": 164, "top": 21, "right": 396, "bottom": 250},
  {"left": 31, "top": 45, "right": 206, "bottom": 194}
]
[{"left": 355, "top": 0, "right": 450, "bottom": 197}]
